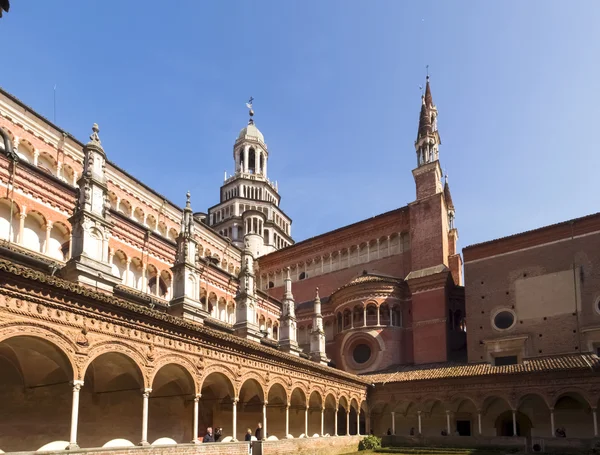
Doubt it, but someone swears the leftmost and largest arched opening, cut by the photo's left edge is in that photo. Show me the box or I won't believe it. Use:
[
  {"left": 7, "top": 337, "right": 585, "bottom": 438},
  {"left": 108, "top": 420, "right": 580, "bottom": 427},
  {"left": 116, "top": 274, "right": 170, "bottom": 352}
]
[{"left": 0, "top": 336, "right": 73, "bottom": 452}]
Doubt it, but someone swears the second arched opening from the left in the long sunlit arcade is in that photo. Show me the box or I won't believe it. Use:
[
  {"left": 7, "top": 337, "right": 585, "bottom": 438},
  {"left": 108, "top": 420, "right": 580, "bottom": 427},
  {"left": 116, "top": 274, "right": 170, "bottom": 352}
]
[{"left": 79, "top": 352, "right": 144, "bottom": 447}]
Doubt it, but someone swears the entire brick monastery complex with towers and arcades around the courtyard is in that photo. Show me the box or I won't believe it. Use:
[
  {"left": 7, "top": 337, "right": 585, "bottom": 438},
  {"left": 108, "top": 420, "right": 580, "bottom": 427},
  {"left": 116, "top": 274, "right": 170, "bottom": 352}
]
[{"left": 0, "top": 78, "right": 600, "bottom": 453}]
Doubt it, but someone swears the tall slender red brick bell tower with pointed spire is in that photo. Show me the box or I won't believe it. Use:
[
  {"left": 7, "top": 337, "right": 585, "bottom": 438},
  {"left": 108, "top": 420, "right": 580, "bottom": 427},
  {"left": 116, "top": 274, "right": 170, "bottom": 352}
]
[{"left": 405, "top": 75, "right": 462, "bottom": 364}]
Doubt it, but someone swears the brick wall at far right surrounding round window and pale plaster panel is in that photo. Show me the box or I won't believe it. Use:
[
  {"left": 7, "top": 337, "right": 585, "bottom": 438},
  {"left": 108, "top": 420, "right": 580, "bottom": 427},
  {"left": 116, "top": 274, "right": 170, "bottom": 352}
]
[{"left": 465, "top": 230, "right": 600, "bottom": 362}]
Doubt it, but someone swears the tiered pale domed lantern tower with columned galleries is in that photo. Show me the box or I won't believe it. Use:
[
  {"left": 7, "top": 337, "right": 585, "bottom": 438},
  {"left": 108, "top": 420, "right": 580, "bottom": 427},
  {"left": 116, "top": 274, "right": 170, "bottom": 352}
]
[{"left": 208, "top": 98, "right": 294, "bottom": 257}]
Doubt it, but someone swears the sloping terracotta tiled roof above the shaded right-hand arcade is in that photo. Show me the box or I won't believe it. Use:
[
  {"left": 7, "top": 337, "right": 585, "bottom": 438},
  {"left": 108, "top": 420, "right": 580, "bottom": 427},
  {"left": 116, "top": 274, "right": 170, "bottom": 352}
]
[{"left": 363, "top": 354, "right": 600, "bottom": 384}]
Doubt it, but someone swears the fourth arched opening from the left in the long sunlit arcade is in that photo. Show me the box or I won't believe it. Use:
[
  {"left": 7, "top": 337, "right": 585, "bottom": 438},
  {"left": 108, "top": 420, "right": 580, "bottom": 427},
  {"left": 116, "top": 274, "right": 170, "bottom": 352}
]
[{"left": 198, "top": 372, "right": 233, "bottom": 440}]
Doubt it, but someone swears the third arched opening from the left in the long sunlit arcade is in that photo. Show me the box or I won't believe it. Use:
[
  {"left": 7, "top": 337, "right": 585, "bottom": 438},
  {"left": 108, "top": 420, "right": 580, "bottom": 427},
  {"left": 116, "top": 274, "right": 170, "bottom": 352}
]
[{"left": 148, "top": 363, "right": 196, "bottom": 443}]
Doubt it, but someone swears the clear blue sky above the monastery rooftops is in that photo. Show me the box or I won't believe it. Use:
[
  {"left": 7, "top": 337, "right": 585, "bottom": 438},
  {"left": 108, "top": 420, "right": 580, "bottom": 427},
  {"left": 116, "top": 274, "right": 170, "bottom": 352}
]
[{"left": 0, "top": 0, "right": 600, "bottom": 246}]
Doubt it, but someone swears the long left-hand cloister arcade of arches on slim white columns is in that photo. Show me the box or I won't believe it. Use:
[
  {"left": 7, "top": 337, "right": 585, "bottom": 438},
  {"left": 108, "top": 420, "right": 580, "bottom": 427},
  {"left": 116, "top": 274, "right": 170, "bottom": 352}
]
[{"left": 0, "top": 335, "right": 365, "bottom": 451}]
